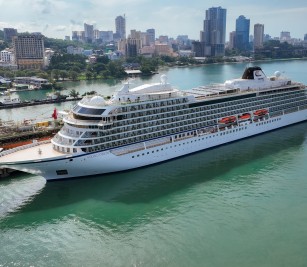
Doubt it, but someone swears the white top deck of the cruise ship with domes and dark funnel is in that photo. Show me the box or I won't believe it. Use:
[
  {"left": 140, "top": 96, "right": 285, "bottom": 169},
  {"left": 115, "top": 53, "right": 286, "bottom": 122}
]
[{"left": 79, "top": 67, "right": 304, "bottom": 112}]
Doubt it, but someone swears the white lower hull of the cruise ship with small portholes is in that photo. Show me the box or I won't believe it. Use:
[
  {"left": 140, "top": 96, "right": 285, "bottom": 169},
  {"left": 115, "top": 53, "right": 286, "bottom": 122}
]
[{"left": 4, "top": 109, "right": 307, "bottom": 180}]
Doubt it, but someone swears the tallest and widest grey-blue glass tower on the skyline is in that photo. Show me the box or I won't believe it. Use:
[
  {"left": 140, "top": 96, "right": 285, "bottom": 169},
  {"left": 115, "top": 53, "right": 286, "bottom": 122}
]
[{"left": 200, "top": 7, "right": 226, "bottom": 56}]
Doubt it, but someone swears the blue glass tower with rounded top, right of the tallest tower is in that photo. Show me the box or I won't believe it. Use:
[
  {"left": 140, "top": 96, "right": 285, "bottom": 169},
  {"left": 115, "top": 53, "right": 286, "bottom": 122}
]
[{"left": 235, "top": 15, "right": 250, "bottom": 50}]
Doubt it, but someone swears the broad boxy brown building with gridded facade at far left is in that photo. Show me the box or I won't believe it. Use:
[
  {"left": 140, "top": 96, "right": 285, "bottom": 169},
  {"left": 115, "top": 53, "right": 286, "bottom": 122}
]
[{"left": 13, "top": 34, "right": 45, "bottom": 69}]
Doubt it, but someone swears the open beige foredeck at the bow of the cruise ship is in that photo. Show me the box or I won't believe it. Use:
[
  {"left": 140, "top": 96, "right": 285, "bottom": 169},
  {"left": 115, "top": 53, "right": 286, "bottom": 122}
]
[{"left": 0, "top": 142, "right": 64, "bottom": 166}]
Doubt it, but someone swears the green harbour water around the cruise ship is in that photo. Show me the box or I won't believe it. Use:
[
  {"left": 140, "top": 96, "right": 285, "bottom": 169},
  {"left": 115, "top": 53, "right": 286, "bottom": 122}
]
[{"left": 0, "top": 61, "right": 307, "bottom": 267}]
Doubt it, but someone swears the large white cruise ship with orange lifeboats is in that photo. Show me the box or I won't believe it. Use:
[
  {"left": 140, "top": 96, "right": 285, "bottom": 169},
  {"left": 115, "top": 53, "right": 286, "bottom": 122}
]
[{"left": 0, "top": 66, "right": 307, "bottom": 180}]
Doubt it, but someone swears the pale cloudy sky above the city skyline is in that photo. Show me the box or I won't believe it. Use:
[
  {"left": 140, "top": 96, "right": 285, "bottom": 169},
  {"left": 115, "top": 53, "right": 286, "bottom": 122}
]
[{"left": 0, "top": 0, "right": 307, "bottom": 40}]
